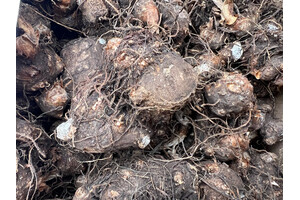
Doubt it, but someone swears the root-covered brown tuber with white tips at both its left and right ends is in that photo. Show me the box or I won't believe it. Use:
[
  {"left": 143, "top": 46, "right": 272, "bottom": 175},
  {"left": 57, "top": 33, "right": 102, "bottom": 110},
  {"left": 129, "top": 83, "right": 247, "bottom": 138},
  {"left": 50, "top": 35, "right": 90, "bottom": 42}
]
[{"left": 56, "top": 85, "right": 150, "bottom": 153}]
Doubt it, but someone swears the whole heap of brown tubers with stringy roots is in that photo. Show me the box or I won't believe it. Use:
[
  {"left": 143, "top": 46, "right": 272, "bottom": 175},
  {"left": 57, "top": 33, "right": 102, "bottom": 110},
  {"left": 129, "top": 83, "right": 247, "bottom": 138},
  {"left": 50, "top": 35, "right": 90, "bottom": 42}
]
[{"left": 16, "top": 0, "right": 283, "bottom": 200}]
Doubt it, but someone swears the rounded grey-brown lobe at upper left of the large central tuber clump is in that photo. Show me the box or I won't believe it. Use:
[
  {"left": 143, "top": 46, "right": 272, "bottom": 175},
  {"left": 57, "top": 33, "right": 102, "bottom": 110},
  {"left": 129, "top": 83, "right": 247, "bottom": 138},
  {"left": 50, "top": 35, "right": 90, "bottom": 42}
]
[{"left": 61, "top": 38, "right": 103, "bottom": 92}]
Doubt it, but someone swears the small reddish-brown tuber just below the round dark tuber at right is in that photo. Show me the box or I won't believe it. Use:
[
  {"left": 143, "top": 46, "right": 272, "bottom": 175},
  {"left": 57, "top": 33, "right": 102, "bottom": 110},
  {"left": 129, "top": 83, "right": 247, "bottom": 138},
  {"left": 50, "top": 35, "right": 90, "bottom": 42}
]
[{"left": 204, "top": 134, "right": 250, "bottom": 161}]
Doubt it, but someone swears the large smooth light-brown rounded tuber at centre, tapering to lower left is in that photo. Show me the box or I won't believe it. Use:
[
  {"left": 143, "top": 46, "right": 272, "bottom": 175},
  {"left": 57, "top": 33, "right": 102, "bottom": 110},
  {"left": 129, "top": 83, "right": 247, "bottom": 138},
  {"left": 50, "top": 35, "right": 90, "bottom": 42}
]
[{"left": 130, "top": 53, "right": 197, "bottom": 110}]
